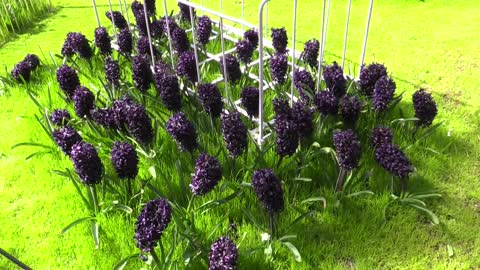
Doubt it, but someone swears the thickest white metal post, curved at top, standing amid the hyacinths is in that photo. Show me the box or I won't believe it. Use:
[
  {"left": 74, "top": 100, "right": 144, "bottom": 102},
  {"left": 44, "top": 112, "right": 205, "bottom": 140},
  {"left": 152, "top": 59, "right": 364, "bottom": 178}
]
[{"left": 257, "top": 0, "right": 270, "bottom": 149}]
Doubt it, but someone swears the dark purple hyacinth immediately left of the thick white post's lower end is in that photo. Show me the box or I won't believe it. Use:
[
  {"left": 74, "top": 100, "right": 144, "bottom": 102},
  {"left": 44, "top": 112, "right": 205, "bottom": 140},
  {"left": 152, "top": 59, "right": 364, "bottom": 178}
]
[{"left": 221, "top": 111, "right": 248, "bottom": 157}]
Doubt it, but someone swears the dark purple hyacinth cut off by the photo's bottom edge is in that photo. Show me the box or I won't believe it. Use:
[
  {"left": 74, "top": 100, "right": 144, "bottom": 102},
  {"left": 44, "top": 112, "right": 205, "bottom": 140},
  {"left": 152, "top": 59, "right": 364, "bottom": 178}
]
[{"left": 208, "top": 236, "right": 238, "bottom": 270}]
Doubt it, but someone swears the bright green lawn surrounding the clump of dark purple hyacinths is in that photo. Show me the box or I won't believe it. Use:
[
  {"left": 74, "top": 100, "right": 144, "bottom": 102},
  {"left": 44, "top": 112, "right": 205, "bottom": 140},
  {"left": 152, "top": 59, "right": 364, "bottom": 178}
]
[{"left": 0, "top": 0, "right": 480, "bottom": 269}]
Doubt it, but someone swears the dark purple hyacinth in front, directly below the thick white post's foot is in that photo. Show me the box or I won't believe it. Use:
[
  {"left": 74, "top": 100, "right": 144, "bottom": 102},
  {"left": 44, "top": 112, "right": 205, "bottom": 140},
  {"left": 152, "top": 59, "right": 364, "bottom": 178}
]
[{"left": 252, "top": 169, "right": 285, "bottom": 214}]
